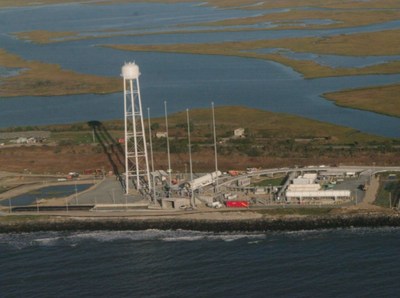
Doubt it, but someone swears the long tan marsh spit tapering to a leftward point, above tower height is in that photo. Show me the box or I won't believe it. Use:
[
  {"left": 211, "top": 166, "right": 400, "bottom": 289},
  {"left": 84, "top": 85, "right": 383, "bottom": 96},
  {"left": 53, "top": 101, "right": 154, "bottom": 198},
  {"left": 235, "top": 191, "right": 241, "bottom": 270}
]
[{"left": 106, "top": 30, "right": 400, "bottom": 78}]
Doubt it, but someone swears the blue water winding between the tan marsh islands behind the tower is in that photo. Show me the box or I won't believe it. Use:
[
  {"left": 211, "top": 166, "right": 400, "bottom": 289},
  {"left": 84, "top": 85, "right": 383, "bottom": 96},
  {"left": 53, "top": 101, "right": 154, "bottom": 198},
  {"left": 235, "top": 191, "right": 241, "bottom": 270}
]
[{"left": 0, "top": 3, "right": 400, "bottom": 137}]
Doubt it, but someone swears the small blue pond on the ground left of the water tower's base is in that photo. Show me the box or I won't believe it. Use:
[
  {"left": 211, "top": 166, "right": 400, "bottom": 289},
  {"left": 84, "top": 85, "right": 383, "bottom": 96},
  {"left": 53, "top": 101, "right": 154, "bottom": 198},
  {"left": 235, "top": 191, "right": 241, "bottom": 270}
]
[{"left": 0, "top": 184, "right": 93, "bottom": 207}]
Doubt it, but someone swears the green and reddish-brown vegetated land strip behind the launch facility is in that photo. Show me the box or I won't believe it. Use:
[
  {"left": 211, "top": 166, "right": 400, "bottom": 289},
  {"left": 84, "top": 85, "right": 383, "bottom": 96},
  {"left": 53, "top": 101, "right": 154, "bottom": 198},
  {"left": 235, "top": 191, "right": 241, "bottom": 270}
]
[{"left": 0, "top": 107, "right": 400, "bottom": 173}]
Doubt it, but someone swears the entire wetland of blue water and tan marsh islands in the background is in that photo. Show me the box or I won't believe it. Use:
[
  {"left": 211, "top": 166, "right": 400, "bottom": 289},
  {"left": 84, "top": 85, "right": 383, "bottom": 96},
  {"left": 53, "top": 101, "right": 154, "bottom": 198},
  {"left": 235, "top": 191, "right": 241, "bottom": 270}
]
[{"left": 0, "top": 0, "right": 400, "bottom": 137}]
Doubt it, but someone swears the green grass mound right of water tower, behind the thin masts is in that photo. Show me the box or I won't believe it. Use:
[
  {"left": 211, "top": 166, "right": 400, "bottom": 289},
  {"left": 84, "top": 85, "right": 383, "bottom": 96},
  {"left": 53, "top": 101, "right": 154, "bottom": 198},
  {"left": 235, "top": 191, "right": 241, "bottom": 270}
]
[{"left": 147, "top": 106, "right": 387, "bottom": 144}]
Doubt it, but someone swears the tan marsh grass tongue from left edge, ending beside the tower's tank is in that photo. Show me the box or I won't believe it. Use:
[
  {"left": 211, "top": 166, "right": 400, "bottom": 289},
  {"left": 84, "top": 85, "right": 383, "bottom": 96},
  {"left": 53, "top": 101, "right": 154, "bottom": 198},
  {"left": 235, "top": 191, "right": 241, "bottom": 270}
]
[{"left": 0, "top": 49, "right": 121, "bottom": 97}]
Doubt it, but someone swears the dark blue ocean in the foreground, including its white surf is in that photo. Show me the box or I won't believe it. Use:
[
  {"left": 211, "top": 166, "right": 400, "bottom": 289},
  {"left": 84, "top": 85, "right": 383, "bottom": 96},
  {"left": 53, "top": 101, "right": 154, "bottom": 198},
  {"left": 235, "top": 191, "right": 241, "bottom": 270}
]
[{"left": 0, "top": 228, "right": 400, "bottom": 297}]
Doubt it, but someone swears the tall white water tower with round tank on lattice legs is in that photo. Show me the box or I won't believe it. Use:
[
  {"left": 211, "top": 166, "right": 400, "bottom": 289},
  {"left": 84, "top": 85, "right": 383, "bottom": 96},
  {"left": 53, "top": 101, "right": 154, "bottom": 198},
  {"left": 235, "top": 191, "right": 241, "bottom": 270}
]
[{"left": 121, "top": 62, "right": 151, "bottom": 194}]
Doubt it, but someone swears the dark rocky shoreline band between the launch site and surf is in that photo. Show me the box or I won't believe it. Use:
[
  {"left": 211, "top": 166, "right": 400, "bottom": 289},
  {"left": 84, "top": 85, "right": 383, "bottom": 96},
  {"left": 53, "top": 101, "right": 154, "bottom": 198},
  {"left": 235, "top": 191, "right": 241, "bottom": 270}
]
[{"left": 0, "top": 213, "right": 400, "bottom": 234}]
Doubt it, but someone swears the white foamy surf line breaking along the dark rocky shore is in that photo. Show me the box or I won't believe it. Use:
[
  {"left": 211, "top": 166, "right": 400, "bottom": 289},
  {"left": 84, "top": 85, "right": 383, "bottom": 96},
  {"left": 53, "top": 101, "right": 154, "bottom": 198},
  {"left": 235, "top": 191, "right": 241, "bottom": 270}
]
[{"left": 0, "top": 227, "right": 400, "bottom": 249}]
